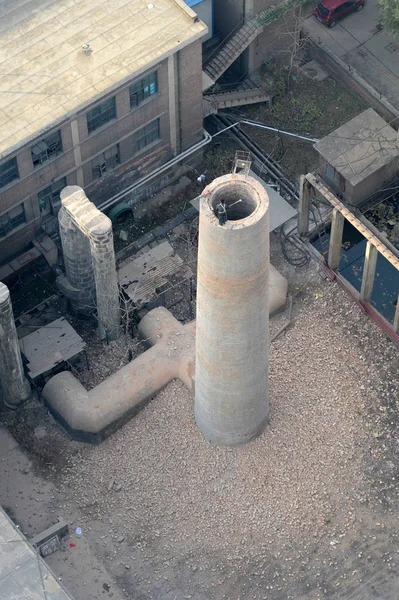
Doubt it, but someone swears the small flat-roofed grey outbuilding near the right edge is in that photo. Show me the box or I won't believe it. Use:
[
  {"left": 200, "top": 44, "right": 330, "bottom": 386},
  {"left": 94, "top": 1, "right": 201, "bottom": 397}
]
[{"left": 314, "top": 108, "right": 399, "bottom": 205}]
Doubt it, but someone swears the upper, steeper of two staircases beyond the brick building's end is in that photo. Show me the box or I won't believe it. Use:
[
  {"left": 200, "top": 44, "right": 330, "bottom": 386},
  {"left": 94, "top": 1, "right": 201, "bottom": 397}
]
[{"left": 203, "top": 18, "right": 263, "bottom": 82}]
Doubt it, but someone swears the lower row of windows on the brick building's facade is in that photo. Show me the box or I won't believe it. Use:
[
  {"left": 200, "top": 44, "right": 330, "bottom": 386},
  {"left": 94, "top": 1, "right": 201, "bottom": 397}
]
[{"left": 0, "top": 119, "right": 161, "bottom": 238}]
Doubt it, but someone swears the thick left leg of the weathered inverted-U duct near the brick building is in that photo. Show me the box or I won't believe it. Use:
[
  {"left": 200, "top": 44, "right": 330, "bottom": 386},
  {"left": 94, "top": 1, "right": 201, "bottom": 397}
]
[{"left": 57, "top": 206, "right": 96, "bottom": 314}]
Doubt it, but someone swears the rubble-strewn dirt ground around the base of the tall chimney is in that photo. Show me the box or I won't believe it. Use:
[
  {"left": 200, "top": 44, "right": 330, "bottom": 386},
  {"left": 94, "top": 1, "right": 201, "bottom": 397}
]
[{"left": 0, "top": 226, "right": 399, "bottom": 600}]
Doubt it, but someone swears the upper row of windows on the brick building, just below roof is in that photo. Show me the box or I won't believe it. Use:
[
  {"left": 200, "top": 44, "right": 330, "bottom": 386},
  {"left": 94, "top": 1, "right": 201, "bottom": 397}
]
[{"left": 0, "top": 72, "right": 158, "bottom": 188}]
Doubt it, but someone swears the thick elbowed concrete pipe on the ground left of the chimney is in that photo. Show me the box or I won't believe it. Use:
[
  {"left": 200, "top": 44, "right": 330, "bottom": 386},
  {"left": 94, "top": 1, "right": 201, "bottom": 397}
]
[{"left": 42, "top": 307, "right": 195, "bottom": 443}]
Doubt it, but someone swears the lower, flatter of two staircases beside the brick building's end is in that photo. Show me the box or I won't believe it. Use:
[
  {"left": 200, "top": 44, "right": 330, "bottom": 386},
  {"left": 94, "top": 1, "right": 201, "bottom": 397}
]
[{"left": 203, "top": 77, "right": 272, "bottom": 117}]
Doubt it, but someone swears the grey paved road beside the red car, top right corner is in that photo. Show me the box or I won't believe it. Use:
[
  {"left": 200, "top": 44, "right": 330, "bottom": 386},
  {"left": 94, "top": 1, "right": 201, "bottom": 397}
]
[{"left": 305, "top": 0, "right": 399, "bottom": 115}]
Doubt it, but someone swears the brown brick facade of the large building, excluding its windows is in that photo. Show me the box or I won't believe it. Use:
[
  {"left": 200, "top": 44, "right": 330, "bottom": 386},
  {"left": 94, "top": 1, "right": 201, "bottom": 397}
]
[{"left": 0, "top": 40, "right": 202, "bottom": 263}]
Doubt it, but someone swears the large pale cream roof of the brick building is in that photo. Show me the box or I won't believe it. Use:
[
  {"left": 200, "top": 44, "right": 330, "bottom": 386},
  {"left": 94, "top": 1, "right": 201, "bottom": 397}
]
[{"left": 0, "top": 0, "right": 207, "bottom": 158}]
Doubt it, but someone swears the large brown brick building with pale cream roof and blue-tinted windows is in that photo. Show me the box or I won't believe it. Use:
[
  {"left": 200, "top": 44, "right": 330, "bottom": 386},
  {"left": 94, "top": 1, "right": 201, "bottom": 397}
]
[{"left": 0, "top": 0, "right": 207, "bottom": 264}]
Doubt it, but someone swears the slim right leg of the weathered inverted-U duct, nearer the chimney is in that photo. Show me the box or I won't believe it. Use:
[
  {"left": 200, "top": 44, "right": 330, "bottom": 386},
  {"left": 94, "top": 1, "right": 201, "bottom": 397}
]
[{"left": 89, "top": 215, "right": 120, "bottom": 340}]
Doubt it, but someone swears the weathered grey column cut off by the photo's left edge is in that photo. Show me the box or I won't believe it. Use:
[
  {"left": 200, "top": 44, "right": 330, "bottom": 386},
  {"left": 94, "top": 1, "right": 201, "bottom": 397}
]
[{"left": 0, "top": 282, "right": 30, "bottom": 408}]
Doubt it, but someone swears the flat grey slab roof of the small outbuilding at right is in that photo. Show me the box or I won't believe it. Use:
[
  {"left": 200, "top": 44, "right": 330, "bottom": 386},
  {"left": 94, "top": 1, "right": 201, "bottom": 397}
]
[{"left": 314, "top": 108, "right": 399, "bottom": 185}]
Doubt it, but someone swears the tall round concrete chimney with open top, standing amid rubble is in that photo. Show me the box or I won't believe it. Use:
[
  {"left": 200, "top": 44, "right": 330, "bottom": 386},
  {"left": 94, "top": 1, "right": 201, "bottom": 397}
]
[{"left": 195, "top": 174, "right": 269, "bottom": 446}]
